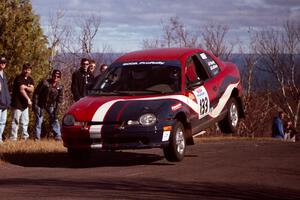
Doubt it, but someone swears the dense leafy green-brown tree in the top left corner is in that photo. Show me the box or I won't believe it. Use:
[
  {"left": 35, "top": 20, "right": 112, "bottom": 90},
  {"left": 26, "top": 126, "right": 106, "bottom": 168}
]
[{"left": 0, "top": 0, "right": 50, "bottom": 83}]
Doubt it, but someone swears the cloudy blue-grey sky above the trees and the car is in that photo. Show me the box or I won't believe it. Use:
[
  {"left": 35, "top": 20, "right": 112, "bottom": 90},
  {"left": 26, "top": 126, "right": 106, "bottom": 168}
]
[{"left": 31, "top": 0, "right": 300, "bottom": 51}]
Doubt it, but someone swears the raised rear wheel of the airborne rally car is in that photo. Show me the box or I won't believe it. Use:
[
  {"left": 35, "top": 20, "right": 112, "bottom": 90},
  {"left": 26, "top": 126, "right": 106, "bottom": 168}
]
[{"left": 219, "top": 97, "right": 239, "bottom": 133}]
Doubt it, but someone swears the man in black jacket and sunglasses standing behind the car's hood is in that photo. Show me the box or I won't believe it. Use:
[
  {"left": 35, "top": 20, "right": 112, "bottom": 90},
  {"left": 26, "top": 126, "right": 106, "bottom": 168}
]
[{"left": 71, "top": 58, "right": 94, "bottom": 101}]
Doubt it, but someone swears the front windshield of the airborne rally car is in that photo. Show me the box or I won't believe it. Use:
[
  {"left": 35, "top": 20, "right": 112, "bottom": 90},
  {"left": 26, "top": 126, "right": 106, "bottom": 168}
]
[{"left": 89, "top": 65, "right": 181, "bottom": 95}]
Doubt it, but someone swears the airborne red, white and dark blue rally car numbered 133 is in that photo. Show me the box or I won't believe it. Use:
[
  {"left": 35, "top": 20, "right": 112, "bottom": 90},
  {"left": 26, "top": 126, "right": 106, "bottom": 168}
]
[{"left": 62, "top": 48, "right": 243, "bottom": 161}]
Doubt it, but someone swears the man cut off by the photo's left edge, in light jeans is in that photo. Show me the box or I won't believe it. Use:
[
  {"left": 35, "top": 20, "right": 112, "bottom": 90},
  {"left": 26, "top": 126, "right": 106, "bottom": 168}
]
[{"left": 0, "top": 57, "right": 11, "bottom": 144}]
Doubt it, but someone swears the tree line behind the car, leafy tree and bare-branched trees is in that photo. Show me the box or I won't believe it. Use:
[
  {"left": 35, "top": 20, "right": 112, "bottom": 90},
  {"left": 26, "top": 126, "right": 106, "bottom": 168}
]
[{"left": 0, "top": 0, "right": 300, "bottom": 137}]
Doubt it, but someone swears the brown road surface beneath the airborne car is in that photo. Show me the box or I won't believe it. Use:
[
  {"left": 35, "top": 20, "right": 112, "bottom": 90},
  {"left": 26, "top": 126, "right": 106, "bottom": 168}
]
[{"left": 0, "top": 140, "right": 300, "bottom": 199}]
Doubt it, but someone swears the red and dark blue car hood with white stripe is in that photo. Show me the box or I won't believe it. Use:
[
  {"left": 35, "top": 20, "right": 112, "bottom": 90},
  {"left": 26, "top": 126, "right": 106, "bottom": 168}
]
[{"left": 67, "top": 95, "right": 183, "bottom": 122}]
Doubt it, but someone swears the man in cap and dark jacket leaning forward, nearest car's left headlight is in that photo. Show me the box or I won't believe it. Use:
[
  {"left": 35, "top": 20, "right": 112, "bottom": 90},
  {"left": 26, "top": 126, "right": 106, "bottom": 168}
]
[{"left": 32, "top": 69, "right": 64, "bottom": 140}]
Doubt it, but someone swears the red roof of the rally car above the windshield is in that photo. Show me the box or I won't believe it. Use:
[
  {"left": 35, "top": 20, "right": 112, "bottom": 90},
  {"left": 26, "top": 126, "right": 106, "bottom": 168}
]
[{"left": 116, "top": 48, "right": 203, "bottom": 62}]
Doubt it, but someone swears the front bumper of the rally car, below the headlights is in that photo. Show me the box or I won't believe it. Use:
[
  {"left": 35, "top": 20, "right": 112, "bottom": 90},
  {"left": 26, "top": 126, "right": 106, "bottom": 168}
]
[{"left": 62, "top": 125, "right": 170, "bottom": 150}]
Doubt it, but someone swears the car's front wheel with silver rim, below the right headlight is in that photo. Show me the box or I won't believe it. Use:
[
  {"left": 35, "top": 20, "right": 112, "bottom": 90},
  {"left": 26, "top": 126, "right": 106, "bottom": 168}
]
[{"left": 163, "top": 121, "right": 186, "bottom": 162}]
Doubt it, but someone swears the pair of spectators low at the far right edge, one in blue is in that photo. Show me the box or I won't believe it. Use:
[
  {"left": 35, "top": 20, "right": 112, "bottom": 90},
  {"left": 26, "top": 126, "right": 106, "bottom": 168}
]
[{"left": 272, "top": 111, "right": 299, "bottom": 142}]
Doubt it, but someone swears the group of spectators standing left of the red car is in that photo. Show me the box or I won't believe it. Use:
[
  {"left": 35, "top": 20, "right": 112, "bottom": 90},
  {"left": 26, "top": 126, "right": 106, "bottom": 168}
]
[{"left": 0, "top": 57, "right": 108, "bottom": 144}]
